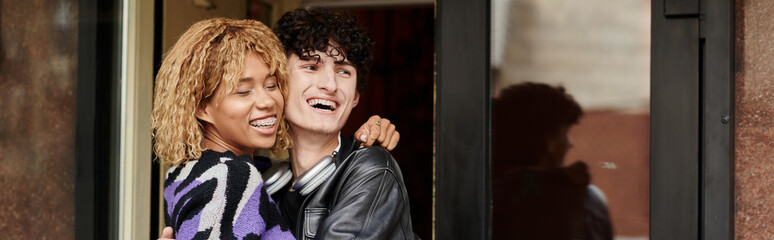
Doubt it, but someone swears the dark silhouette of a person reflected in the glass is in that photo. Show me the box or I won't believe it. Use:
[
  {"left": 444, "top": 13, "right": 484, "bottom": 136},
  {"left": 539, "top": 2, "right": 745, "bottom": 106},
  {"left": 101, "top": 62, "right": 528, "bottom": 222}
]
[{"left": 492, "top": 83, "right": 613, "bottom": 240}]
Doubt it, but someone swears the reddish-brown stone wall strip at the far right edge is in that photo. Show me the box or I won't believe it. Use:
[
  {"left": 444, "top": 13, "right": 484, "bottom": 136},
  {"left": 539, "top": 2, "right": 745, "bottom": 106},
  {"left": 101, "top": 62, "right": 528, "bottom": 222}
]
[{"left": 735, "top": 0, "right": 774, "bottom": 239}]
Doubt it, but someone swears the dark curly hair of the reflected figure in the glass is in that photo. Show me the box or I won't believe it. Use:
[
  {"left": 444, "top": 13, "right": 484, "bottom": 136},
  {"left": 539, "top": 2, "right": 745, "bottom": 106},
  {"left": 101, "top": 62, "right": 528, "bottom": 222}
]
[{"left": 492, "top": 82, "right": 583, "bottom": 166}]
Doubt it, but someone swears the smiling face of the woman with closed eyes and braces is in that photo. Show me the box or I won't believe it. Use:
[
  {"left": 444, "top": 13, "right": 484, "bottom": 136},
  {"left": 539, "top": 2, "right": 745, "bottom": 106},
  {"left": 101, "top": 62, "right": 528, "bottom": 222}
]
[{"left": 196, "top": 53, "right": 284, "bottom": 155}]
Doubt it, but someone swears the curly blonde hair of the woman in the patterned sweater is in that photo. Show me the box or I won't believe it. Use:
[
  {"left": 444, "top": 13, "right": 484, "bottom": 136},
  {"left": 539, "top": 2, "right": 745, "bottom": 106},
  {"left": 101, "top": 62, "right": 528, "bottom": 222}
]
[{"left": 152, "top": 18, "right": 291, "bottom": 165}]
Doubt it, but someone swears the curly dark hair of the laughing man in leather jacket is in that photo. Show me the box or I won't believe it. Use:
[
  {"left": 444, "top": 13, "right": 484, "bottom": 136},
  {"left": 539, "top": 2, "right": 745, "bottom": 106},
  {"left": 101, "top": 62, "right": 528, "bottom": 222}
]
[{"left": 274, "top": 8, "right": 374, "bottom": 93}]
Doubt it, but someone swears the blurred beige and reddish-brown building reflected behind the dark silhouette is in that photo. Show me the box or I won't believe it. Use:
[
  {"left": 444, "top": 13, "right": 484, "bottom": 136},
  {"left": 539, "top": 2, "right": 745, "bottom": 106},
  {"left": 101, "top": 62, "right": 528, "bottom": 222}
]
[{"left": 492, "top": 0, "right": 650, "bottom": 238}]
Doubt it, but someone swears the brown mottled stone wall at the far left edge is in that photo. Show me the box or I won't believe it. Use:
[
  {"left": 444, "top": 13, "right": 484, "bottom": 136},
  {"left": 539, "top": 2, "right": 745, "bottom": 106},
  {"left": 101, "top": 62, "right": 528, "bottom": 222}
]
[{"left": 0, "top": 0, "right": 78, "bottom": 239}]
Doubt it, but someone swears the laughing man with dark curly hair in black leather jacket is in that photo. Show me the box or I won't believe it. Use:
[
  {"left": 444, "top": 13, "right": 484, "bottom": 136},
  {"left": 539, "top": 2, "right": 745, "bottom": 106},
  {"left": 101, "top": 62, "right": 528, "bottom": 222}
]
[{"left": 272, "top": 9, "right": 414, "bottom": 239}]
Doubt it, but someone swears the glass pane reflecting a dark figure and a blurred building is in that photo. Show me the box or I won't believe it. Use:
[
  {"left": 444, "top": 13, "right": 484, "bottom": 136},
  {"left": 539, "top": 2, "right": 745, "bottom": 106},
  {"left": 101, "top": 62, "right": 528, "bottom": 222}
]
[{"left": 492, "top": 0, "right": 650, "bottom": 239}]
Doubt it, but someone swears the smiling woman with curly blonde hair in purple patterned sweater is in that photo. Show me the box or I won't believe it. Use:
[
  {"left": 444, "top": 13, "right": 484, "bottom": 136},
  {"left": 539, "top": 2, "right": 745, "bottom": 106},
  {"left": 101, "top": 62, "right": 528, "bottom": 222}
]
[{"left": 152, "top": 18, "right": 293, "bottom": 239}]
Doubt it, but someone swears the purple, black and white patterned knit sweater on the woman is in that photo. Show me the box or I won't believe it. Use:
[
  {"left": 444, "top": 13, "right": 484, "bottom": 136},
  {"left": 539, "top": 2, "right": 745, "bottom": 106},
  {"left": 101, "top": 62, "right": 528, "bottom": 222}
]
[{"left": 164, "top": 150, "right": 294, "bottom": 239}]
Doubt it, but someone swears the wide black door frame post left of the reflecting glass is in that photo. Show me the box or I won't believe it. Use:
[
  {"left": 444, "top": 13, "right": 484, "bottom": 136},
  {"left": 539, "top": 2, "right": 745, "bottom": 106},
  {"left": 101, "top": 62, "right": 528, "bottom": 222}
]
[{"left": 433, "top": 0, "right": 492, "bottom": 239}]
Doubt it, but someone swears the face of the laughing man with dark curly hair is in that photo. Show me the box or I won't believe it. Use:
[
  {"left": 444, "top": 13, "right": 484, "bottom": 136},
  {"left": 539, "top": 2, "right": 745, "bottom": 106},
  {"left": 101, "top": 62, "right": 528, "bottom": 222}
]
[{"left": 285, "top": 46, "right": 360, "bottom": 134}]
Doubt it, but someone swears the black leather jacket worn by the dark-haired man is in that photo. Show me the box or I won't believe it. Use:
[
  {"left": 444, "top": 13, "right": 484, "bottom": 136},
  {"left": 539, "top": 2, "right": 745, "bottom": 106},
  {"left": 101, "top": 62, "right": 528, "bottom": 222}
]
[{"left": 274, "top": 138, "right": 417, "bottom": 239}]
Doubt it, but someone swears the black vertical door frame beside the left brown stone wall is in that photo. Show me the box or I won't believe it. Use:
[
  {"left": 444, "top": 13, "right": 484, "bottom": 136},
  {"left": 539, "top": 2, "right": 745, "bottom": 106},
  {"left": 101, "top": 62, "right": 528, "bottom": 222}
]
[{"left": 74, "top": 0, "right": 122, "bottom": 239}]
